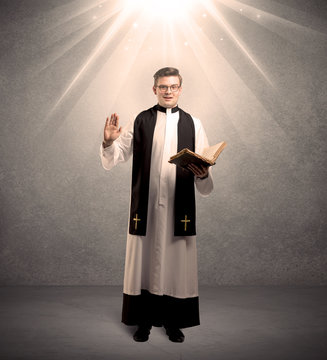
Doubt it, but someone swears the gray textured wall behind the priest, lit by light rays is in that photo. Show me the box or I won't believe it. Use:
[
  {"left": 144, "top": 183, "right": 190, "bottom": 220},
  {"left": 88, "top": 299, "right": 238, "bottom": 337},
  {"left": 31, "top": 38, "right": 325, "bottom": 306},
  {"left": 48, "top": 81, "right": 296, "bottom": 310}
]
[{"left": 0, "top": 0, "right": 327, "bottom": 285}]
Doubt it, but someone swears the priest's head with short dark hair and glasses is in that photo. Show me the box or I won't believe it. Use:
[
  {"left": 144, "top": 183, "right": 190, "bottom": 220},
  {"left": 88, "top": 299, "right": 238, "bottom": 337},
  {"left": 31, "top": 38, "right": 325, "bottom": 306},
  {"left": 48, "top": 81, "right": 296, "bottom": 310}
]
[{"left": 153, "top": 67, "right": 182, "bottom": 108}]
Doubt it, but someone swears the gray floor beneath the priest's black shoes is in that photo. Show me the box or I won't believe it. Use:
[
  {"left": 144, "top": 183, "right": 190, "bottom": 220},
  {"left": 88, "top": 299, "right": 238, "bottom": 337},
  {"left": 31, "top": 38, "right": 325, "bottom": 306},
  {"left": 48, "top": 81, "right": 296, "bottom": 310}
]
[{"left": 0, "top": 287, "right": 327, "bottom": 360}]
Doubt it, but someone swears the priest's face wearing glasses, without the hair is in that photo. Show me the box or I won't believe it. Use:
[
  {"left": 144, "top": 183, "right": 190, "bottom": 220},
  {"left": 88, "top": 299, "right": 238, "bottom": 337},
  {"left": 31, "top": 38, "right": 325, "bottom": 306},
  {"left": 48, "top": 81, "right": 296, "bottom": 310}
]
[{"left": 153, "top": 76, "right": 182, "bottom": 108}]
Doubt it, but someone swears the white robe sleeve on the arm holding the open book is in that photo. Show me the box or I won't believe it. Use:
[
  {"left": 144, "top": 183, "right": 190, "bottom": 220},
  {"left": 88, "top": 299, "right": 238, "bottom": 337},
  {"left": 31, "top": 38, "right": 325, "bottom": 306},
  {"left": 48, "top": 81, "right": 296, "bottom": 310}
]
[{"left": 193, "top": 118, "right": 213, "bottom": 196}]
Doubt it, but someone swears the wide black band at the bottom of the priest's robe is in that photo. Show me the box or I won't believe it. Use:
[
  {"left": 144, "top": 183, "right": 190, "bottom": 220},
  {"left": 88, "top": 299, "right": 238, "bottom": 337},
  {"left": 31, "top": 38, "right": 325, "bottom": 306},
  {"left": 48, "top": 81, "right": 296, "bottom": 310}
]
[{"left": 122, "top": 290, "right": 200, "bottom": 329}]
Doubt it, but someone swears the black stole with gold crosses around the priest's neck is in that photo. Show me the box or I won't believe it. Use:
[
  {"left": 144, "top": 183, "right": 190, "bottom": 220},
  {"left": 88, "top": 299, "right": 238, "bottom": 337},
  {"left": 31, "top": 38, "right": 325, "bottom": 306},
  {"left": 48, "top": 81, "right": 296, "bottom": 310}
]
[{"left": 129, "top": 105, "right": 196, "bottom": 236}]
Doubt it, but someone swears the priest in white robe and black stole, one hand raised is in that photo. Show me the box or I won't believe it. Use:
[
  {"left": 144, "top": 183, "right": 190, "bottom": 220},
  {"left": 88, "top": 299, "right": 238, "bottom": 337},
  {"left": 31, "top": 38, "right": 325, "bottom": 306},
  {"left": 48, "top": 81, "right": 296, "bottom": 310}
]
[{"left": 100, "top": 67, "right": 213, "bottom": 342}]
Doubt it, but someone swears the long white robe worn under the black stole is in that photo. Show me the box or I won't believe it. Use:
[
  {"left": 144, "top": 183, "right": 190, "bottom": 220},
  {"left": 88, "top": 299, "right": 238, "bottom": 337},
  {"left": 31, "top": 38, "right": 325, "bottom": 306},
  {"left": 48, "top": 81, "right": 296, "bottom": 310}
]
[{"left": 100, "top": 109, "right": 213, "bottom": 299}]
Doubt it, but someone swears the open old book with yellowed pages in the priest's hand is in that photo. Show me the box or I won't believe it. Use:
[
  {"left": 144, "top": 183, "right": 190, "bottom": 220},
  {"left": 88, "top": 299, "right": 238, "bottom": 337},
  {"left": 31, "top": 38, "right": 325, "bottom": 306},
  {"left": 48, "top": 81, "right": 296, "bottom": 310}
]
[{"left": 169, "top": 141, "right": 227, "bottom": 167}]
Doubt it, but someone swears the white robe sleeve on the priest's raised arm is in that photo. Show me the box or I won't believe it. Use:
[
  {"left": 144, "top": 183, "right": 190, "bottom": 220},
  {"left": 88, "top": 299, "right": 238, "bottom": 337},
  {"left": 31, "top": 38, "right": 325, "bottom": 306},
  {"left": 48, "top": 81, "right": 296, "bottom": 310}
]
[{"left": 100, "top": 120, "right": 134, "bottom": 170}]
